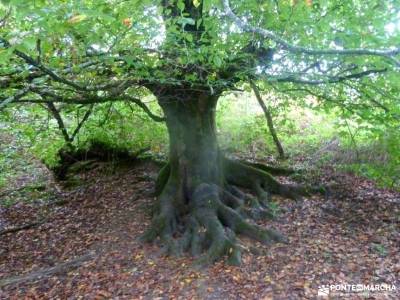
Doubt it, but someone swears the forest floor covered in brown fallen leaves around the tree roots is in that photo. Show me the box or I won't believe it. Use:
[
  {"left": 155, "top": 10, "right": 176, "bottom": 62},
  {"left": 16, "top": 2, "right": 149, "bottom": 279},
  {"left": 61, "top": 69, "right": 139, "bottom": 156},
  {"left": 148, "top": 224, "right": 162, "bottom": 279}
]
[{"left": 0, "top": 156, "right": 400, "bottom": 299}]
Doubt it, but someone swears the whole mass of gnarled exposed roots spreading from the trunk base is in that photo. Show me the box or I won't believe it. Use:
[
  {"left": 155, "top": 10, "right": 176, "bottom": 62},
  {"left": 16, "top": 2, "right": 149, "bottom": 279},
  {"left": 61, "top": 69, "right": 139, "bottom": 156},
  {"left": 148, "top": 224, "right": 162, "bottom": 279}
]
[{"left": 143, "top": 159, "right": 321, "bottom": 264}]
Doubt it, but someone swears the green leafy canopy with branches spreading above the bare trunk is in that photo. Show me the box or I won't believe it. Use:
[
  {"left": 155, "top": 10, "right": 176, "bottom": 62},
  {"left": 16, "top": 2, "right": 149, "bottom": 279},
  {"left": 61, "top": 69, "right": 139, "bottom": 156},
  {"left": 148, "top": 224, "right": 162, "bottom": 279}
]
[{"left": 0, "top": 0, "right": 400, "bottom": 122}]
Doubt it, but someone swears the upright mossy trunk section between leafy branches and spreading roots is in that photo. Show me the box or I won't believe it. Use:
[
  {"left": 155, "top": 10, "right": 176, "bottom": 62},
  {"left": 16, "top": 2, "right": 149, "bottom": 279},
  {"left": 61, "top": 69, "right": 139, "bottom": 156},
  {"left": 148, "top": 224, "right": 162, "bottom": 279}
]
[{"left": 160, "top": 94, "right": 222, "bottom": 198}]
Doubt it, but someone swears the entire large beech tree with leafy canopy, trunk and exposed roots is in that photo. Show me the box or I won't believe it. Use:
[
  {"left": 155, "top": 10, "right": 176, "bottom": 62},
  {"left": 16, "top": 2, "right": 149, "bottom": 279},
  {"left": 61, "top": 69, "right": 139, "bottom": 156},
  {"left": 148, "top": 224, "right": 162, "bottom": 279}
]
[{"left": 0, "top": 0, "right": 400, "bottom": 263}]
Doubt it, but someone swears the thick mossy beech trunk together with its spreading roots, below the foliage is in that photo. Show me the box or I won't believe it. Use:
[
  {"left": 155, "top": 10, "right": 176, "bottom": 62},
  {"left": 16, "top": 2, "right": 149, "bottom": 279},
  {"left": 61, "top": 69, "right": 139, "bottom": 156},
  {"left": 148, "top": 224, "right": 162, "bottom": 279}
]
[{"left": 143, "top": 89, "right": 320, "bottom": 264}]
